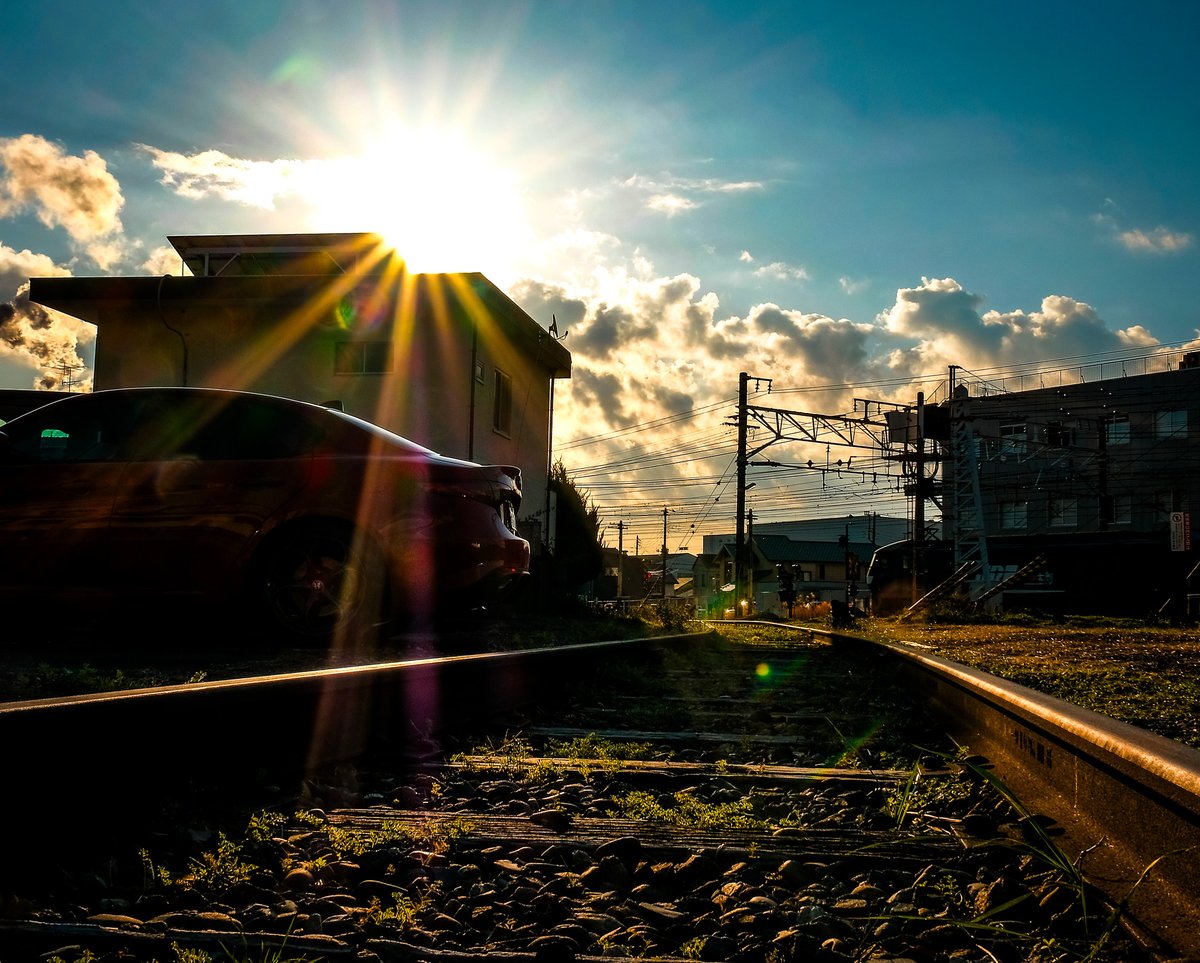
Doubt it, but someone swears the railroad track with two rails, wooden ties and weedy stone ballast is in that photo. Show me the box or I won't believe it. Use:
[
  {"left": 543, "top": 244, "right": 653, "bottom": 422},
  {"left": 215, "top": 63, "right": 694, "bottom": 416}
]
[{"left": 0, "top": 627, "right": 1200, "bottom": 963}]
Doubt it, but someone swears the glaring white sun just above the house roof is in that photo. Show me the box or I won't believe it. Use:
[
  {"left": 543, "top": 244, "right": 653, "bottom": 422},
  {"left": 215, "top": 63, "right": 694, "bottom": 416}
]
[{"left": 302, "top": 127, "right": 528, "bottom": 283}]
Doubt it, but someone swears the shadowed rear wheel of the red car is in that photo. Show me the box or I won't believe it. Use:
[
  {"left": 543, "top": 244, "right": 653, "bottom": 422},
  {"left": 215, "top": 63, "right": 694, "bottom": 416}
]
[{"left": 259, "top": 525, "right": 382, "bottom": 641}]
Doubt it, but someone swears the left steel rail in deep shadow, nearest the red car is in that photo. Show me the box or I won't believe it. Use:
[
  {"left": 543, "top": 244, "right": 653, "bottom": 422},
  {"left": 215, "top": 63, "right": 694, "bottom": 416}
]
[{"left": 0, "top": 633, "right": 707, "bottom": 875}]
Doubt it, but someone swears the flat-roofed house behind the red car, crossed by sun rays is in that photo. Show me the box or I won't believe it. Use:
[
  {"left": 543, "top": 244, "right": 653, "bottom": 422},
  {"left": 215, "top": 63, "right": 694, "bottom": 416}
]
[{"left": 30, "top": 234, "right": 571, "bottom": 543}]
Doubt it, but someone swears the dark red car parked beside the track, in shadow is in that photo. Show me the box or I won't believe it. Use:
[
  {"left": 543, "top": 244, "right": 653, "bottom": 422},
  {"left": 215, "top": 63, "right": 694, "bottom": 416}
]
[{"left": 0, "top": 388, "right": 529, "bottom": 639}]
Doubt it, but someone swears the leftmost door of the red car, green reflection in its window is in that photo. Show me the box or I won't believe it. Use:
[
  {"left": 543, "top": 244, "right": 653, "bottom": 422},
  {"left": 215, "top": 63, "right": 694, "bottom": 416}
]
[{"left": 0, "top": 394, "right": 132, "bottom": 594}]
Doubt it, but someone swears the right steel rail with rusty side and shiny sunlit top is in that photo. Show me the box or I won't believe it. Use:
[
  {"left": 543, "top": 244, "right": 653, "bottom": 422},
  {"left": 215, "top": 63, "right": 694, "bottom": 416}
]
[{"left": 715, "top": 622, "right": 1200, "bottom": 957}]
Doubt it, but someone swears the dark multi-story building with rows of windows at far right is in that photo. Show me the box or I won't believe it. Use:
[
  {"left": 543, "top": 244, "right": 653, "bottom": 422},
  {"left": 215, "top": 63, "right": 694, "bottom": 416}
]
[{"left": 916, "top": 354, "right": 1200, "bottom": 615}]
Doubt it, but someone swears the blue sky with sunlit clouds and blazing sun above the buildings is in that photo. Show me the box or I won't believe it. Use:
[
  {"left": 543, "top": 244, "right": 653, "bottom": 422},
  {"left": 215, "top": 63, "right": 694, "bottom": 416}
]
[{"left": 0, "top": 0, "right": 1200, "bottom": 535}]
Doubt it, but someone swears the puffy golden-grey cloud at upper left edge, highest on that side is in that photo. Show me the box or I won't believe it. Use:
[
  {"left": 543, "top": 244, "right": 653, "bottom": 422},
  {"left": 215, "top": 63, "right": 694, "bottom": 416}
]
[{"left": 0, "top": 133, "right": 125, "bottom": 268}]
